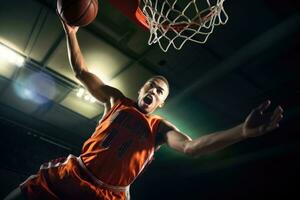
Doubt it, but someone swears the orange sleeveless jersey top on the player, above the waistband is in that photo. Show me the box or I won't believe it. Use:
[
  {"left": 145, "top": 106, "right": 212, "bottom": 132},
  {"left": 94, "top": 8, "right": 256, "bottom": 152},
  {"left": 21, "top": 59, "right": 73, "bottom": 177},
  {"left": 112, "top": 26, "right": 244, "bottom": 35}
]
[{"left": 80, "top": 98, "right": 161, "bottom": 186}]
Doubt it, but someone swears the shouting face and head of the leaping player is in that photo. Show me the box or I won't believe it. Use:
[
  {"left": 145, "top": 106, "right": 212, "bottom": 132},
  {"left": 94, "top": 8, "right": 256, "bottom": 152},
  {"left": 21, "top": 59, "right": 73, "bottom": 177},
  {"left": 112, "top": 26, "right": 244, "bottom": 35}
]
[{"left": 138, "top": 78, "right": 169, "bottom": 113}]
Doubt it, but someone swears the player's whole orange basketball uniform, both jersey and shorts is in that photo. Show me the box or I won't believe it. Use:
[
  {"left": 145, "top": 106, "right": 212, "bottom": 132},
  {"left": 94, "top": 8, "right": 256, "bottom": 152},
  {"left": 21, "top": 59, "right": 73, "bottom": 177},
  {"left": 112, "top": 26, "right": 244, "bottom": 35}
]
[{"left": 20, "top": 98, "right": 160, "bottom": 200}]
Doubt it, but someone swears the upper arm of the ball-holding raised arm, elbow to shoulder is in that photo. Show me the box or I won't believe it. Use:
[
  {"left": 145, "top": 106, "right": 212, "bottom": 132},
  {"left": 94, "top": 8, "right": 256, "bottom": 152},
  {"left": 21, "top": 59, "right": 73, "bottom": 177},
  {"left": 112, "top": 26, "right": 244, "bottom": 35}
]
[{"left": 77, "top": 71, "right": 123, "bottom": 103}]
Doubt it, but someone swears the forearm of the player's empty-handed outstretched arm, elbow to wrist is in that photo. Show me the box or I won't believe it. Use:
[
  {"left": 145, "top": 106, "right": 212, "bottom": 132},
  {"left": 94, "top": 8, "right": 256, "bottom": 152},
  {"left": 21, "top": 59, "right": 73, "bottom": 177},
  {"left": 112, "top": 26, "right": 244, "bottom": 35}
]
[{"left": 186, "top": 124, "right": 245, "bottom": 157}]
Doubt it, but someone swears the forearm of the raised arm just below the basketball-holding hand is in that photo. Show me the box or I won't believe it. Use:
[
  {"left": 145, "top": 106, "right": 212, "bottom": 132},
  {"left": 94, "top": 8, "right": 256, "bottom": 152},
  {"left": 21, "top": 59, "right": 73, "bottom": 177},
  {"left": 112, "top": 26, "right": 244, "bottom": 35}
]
[{"left": 66, "top": 33, "right": 88, "bottom": 77}]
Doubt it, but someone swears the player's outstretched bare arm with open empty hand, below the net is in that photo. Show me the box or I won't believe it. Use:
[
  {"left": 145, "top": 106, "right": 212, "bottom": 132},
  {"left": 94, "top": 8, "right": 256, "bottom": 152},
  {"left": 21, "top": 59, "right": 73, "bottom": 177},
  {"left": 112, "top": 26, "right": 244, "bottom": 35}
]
[{"left": 161, "top": 101, "right": 283, "bottom": 157}]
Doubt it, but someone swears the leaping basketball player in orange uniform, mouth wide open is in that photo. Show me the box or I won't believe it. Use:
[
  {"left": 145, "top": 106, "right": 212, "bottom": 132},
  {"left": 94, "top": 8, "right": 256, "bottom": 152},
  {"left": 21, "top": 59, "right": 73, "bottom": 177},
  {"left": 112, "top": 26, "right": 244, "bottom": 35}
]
[{"left": 6, "top": 16, "right": 283, "bottom": 200}]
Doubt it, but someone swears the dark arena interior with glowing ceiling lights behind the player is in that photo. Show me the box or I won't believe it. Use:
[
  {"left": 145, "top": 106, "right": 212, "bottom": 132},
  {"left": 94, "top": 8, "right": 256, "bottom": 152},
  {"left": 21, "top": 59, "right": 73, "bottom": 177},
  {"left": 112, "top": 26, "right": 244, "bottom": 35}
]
[{"left": 0, "top": 0, "right": 300, "bottom": 200}]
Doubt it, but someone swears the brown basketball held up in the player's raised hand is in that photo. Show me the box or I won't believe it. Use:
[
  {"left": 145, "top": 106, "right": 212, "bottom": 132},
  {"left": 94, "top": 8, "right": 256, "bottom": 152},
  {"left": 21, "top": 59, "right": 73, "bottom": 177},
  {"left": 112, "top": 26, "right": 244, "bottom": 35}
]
[{"left": 57, "top": 0, "right": 98, "bottom": 26}]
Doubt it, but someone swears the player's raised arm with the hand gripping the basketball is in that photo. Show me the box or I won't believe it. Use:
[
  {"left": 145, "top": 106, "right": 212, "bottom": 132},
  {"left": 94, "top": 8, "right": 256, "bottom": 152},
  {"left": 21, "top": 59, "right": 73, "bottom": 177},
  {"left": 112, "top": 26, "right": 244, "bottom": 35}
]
[{"left": 61, "top": 20, "right": 123, "bottom": 106}]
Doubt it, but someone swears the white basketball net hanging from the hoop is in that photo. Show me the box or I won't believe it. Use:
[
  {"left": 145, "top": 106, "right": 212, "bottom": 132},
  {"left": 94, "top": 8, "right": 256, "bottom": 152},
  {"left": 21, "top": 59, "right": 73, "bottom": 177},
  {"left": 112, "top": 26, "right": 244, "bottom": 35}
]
[{"left": 141, "top": 0, "right": 228, "bottom": 52}]
